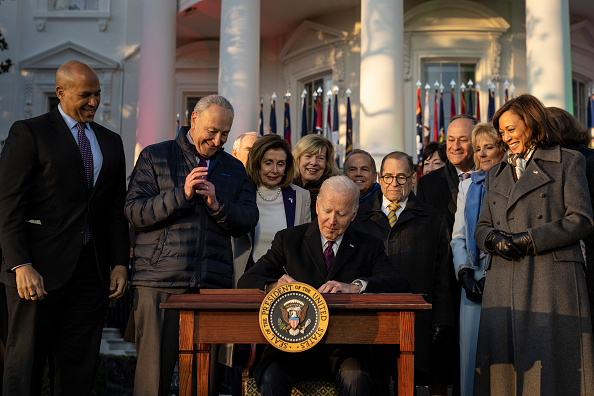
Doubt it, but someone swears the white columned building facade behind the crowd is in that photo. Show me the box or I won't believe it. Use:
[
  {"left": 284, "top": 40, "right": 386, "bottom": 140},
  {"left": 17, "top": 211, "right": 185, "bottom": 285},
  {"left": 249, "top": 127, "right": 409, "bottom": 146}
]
[{"left": 0, "top": 0, "right": 594, "bottom": 172}]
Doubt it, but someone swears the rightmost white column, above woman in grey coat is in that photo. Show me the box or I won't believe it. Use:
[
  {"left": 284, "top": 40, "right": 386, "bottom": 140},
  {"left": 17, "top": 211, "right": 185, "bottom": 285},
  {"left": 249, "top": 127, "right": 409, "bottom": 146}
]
[{"left": 526, "top": 0, "right": 573, "bottom": 112}]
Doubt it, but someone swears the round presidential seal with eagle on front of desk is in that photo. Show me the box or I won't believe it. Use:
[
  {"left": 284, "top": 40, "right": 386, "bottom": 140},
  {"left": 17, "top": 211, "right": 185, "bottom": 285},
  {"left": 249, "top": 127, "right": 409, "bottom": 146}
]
[{"left": 260, "top": 282, "right": 329, "bottom": 352}]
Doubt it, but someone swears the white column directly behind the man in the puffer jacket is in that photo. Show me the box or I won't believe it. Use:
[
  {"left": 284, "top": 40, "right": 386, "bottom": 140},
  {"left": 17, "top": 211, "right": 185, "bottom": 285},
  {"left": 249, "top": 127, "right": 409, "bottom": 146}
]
[{"left": 219, "top": 0, "right": 260, "bottom": 145}]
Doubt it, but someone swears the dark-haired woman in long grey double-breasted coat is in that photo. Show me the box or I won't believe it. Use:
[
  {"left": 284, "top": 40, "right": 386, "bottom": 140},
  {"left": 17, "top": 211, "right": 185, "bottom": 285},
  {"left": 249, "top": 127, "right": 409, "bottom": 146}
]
[{"left": 474, "top": 95, "right": 594, "bottom": 396}]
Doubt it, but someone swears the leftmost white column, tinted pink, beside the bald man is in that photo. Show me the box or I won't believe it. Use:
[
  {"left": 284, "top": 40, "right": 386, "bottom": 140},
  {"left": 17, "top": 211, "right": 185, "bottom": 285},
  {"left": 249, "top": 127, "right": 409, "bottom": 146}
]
[{"left": 135, "top": 0, "right": 177, "bottom": 157}]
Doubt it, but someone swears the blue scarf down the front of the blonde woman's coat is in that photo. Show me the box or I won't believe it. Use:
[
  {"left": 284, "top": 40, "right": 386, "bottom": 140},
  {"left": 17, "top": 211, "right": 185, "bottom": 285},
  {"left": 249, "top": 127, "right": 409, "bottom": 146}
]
[{"left": 464, "top": 171, "right": 485, "bottom": 270}]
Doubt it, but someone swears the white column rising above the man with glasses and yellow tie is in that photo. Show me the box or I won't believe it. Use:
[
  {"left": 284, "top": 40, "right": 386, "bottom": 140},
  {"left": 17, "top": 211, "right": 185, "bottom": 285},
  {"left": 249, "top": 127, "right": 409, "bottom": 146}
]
[{"left": 359, "top": 0, "right": 404, "bottom": 161}]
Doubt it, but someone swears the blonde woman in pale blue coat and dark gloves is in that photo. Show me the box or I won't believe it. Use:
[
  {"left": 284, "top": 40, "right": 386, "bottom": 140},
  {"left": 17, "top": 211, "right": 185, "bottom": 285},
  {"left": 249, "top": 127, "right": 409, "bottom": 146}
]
[{"left": 451, "top": 123, "right": 505, "bottom": 396}]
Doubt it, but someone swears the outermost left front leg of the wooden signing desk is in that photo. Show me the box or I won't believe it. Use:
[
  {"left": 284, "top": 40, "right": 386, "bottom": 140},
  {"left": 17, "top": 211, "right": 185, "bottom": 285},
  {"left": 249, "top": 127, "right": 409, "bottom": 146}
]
[{"left": 179, "top": 311, "right": 194, "bottom": 396}]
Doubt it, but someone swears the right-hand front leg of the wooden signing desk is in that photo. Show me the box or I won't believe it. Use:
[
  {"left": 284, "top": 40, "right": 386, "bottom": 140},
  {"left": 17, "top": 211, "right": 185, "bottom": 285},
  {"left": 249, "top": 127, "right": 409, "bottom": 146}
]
[{"left": 398, "top": 312, "right": 415, "bottom": 396}]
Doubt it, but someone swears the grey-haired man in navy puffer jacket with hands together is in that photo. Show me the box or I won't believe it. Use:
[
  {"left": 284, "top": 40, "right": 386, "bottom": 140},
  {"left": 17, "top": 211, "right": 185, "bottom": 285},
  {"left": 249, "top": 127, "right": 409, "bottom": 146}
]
[{"left": 125, "top": 95, "right": 258, "bottom": 396}]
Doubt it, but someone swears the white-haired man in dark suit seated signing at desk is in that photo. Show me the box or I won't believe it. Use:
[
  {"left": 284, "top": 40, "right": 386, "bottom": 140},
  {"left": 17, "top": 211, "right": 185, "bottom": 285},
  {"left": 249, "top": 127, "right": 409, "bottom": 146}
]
[{"left": 238, "top": 176, "right": 409, "bottom": 396}]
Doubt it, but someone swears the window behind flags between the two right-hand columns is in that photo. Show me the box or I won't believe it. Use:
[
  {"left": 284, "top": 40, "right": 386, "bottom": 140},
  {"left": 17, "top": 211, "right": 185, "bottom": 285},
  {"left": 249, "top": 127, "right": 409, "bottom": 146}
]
[{"left": 421, "top": 60, "right": 474, "bottom": 138}]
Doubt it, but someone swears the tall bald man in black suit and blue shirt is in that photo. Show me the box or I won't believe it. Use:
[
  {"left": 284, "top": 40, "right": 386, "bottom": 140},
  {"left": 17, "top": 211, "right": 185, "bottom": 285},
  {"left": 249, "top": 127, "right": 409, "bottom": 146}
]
[{"left": 0, "top": 61, "right": 129, "bottom": 396}]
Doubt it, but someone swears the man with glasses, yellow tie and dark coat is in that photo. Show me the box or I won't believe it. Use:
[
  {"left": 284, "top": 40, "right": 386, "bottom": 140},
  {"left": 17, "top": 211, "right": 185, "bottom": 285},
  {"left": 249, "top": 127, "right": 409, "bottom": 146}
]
[{"left": 353, "top": 151, "right": 457, "bottom": 394}]
